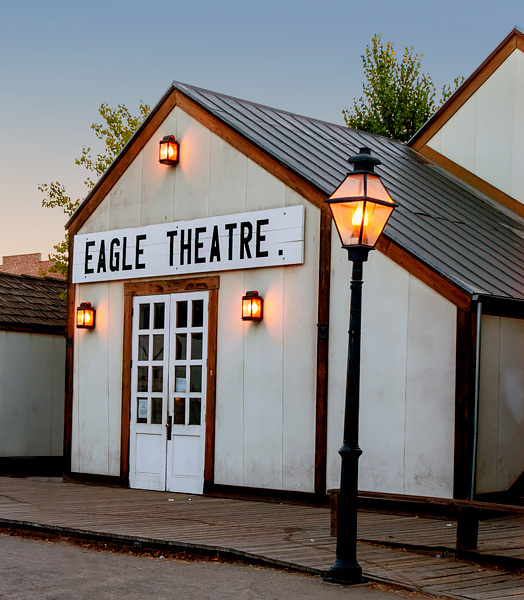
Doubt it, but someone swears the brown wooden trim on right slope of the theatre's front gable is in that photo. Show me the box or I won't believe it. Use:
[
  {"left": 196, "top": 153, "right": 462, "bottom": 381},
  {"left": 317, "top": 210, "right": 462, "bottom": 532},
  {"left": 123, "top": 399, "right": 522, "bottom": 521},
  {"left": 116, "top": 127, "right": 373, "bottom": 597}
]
[{"left": 176, "top": 90, "right": 331, "bottom": 214}]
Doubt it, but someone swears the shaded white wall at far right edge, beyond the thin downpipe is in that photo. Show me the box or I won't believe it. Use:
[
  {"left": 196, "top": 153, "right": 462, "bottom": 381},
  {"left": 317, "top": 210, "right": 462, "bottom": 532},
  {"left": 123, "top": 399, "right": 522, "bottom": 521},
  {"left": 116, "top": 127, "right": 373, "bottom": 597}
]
[{"left": 476, "top": 316, "right": 524, "bottom": 493}]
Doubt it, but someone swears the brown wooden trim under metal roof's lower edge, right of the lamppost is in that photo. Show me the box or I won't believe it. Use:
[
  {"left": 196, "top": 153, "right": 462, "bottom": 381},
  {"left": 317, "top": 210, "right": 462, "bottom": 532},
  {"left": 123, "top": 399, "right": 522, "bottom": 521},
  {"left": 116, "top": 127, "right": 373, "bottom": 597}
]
[{"left": 376, "top": 234, "right": 471, "bottom": 312}]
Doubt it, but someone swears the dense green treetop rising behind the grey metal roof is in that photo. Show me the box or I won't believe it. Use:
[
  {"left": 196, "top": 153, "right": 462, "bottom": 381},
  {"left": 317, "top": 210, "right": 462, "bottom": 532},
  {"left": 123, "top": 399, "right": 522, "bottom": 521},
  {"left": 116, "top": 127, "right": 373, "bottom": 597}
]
[{"left": 342, "top": 34, "right": 464, "bottom": 142}]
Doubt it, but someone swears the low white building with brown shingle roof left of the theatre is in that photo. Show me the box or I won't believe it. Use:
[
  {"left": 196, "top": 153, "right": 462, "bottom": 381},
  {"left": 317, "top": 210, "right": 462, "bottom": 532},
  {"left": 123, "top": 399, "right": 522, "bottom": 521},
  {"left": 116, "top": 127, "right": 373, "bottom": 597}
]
[{"left": 0, "top": 273, "right": 66, "bottom": 475}]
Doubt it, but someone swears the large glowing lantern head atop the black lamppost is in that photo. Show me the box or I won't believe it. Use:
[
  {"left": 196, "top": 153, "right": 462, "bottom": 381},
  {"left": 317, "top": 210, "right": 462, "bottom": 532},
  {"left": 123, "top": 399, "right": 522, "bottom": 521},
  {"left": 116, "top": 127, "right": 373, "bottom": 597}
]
[{"left": 327, "top": 148, "right": 398, "bottom": 260}]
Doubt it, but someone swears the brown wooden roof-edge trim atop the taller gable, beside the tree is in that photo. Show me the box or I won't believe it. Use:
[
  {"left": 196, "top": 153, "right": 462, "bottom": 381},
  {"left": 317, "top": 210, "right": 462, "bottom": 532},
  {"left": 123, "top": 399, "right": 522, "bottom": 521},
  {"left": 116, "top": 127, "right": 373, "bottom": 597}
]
[{"left": 408, "top": 28, "right": 524, "bottom": 150}]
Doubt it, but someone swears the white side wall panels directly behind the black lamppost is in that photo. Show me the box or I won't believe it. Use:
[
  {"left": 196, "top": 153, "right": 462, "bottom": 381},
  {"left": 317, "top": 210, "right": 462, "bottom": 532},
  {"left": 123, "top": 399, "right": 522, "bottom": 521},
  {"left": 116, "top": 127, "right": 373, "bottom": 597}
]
[{"left": 327, "top": 232, "right": 456, "bottom": 498}]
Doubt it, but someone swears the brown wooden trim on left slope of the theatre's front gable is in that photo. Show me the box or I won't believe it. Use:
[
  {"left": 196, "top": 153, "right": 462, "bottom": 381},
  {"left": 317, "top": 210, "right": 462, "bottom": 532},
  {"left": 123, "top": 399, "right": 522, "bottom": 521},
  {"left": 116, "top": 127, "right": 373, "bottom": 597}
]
[{"left": 66, "top": 88, "right": 180, "bottom": 235}]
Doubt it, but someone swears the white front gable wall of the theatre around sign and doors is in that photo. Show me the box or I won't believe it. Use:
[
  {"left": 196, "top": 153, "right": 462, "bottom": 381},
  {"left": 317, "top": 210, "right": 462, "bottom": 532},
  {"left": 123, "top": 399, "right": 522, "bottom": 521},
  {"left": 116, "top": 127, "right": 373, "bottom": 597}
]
[{"left": 72, "top": 108, "right": 320, "bottom": 492}]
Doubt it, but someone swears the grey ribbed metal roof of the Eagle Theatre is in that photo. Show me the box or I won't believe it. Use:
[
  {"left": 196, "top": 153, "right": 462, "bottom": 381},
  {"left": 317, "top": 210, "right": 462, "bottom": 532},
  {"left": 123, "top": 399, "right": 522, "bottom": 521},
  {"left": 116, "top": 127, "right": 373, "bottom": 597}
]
[{"left": 173, "top": 82, "right": 524, "bottom": 299}]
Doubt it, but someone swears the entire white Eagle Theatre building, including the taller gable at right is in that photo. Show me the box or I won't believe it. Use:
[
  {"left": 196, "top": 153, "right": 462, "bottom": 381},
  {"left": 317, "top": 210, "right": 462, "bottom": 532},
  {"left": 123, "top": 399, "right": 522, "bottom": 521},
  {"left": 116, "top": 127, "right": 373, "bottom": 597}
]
[{"left": 65, "top": 31, "right": 524, "bottom": 498}]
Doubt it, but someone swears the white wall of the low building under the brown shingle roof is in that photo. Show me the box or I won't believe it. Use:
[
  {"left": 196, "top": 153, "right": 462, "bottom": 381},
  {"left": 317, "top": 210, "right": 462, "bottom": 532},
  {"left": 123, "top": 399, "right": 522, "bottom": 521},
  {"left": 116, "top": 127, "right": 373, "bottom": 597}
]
[{"left": 0, "top": 331, "right": 65, "bottom": 458}]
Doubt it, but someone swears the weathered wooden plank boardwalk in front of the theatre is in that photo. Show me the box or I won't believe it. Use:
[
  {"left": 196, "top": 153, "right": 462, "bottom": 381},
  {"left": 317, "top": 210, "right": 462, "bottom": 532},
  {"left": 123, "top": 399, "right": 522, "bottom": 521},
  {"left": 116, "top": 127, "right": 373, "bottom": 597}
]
[{"left": 0, "top": 477, "right": 524, "bottom": 600}]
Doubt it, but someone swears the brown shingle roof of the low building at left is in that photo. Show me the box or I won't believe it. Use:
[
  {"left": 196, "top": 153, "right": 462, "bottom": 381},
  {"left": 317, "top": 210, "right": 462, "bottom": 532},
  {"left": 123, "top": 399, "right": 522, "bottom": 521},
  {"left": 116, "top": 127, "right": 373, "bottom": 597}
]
[{"left": 0, "top": 273, "right": 67, "bottom": 333}]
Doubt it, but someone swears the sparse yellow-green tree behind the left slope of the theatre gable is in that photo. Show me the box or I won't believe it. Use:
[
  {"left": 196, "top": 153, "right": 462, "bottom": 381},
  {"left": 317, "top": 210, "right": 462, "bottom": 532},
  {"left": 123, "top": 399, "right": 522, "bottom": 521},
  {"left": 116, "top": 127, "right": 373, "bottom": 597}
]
[{"left": 38, "top": 102, "right": 151, "bottom": 276}]
